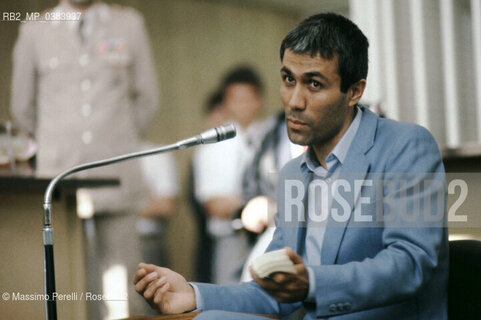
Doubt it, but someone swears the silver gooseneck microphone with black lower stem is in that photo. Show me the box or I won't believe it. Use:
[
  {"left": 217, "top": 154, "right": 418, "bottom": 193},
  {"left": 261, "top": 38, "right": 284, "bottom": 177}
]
[{"left": 42, "top": 123, "right": 236, "bottom": 320}]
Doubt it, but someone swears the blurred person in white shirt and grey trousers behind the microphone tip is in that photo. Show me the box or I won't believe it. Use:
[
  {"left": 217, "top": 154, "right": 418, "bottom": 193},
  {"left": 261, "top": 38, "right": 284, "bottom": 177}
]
[{"left": 194, "top": 66, "right": 262, "bottom": 284}]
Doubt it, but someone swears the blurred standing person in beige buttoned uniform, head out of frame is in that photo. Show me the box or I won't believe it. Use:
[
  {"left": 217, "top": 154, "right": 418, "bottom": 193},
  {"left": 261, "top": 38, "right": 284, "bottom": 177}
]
[{"left": 11, "top": 0, "right": 158, "bottom": 319}]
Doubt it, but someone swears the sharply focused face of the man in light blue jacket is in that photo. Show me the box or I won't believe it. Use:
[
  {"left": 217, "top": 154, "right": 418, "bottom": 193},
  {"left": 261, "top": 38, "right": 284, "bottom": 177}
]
[{"left": 280, "top": 49, "right": 352, "bottom": 147}]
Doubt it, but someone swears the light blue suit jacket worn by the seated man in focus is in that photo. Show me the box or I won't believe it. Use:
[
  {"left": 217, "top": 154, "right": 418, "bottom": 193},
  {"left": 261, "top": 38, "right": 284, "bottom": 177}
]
[{"left": 196, "top": 108, "right": 448, "bottom": 320}]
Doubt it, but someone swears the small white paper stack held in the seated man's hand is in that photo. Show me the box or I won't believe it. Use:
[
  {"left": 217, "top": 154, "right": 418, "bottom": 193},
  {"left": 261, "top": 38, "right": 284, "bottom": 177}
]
[{"left": 252, "top": 249, "right": 296, "bottom": 278}]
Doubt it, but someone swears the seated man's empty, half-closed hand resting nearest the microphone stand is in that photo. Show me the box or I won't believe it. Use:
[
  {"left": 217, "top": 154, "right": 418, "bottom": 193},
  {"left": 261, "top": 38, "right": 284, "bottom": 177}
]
[{"left": 133, "top": 263, "right": 196, "bottom": 314}]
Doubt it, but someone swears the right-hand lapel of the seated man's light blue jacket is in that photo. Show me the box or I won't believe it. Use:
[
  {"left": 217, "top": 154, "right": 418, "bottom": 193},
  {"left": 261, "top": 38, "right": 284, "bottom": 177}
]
[{"left": 321, "top": 108, "right": 378, "bottom": 265}]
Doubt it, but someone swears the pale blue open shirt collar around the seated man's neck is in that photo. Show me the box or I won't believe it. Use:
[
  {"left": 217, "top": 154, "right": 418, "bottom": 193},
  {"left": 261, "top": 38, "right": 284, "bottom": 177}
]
[{"left": 300, "top": 106, "right": 362, "bottom": 171}]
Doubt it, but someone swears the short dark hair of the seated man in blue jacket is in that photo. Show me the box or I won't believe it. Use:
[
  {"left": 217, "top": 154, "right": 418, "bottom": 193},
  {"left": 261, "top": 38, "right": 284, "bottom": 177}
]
[{"left": 280, "top": 13, "right": 369, "bottom": 92}]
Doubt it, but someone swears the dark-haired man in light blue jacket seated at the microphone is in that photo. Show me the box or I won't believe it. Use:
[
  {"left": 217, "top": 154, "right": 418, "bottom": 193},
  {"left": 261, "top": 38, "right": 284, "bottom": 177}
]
[{"left": 134, "top": 14, "right": 448, "bottom": 320}]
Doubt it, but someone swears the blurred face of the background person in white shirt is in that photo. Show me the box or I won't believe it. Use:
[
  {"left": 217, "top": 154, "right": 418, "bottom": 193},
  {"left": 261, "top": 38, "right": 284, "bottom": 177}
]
[{"left": 224, "top": 83, "right": 262, "bottom": 127}]
